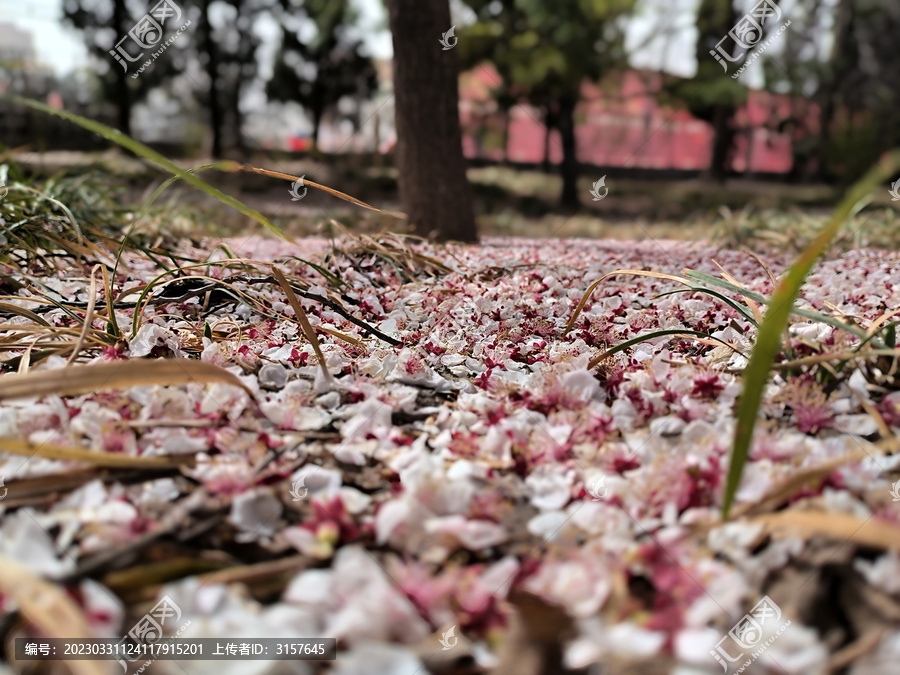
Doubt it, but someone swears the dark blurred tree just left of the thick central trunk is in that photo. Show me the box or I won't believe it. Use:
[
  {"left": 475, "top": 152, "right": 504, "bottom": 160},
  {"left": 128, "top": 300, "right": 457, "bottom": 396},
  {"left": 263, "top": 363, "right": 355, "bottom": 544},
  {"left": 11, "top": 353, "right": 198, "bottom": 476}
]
[{"left": 266, "top": 0, "right": 378, "bottom": 146}]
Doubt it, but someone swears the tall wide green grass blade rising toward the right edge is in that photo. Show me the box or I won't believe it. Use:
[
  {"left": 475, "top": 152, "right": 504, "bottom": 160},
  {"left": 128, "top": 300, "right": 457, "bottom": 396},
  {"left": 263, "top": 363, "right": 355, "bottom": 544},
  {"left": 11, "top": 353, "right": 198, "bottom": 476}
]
[{"left": 722, "top": 150, "right": 900, "bottom": 519}]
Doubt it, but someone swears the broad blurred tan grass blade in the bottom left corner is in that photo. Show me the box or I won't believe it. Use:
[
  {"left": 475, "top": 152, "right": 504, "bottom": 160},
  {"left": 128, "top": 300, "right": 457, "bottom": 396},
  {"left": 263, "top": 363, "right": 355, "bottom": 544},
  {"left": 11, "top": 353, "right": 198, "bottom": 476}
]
[{"left": 0, "top": 557, "right": 112, "bottom": 675}]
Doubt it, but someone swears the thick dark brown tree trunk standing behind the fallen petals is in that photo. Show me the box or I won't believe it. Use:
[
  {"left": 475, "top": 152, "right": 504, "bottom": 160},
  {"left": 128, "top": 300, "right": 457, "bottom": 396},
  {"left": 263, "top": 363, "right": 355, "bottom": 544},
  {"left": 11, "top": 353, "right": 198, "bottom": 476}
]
[{"left": 387, "top": 0, "right": 477, "bottom": 242}]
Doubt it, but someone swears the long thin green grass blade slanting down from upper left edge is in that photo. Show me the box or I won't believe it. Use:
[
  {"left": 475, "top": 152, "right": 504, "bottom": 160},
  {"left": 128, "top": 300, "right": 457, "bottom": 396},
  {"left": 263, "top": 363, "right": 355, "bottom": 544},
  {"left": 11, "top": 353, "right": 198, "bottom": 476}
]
[{"left": 0, "top": 96, "right": 287, "bottom": 239}]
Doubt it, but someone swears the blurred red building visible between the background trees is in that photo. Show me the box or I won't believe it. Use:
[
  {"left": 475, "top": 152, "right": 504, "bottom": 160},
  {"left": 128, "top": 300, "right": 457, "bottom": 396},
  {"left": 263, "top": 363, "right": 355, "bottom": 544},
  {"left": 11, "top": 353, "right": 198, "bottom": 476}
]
[{"left": 460, "top": 65, "right": 804, "bottom": 174}]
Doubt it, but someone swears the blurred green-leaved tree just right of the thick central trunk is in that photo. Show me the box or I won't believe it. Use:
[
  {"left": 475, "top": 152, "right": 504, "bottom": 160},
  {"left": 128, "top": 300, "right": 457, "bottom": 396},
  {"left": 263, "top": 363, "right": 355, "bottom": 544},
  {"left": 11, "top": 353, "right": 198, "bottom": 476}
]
[{"left": 460, "top": 0, "right": 635, "bottom": 207}]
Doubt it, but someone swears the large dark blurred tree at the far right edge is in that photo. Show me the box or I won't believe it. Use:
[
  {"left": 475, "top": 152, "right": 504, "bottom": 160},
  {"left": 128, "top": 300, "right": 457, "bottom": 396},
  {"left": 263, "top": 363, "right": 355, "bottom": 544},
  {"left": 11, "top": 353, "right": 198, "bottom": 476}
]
[{"left": 763, "top": 0, "right": 900, "bottom": 184}]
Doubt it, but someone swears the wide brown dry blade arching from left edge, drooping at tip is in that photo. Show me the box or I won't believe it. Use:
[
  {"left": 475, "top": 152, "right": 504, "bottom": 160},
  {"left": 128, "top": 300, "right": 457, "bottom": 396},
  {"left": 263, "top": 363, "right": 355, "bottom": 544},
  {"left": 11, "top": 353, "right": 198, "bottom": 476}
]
[{"left": 0, "top": 359, "right": 253, "bottom": 401}]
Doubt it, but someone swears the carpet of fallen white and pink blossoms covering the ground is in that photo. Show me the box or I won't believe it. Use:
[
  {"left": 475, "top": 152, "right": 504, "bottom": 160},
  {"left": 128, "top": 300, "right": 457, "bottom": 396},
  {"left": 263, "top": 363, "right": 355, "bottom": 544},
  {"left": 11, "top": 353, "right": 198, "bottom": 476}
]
[{"left": 0, "top": 238, "right": 900, "bottom": 675}]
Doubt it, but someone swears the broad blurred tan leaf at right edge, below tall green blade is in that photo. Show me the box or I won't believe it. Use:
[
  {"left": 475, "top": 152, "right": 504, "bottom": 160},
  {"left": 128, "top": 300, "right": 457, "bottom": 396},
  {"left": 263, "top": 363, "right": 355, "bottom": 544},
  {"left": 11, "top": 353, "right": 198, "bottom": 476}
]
[{"left": 748, "top": 511, "right": 900, "bottom": 551}]
